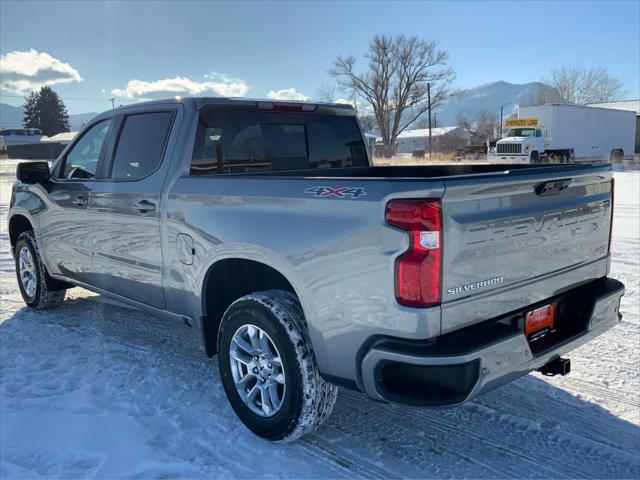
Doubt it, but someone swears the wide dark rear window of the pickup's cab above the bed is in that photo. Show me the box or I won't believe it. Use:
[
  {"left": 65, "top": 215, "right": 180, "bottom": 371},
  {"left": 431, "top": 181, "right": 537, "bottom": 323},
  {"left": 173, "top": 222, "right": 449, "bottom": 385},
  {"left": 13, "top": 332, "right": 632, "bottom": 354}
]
[{"left": 191, "top": 108, "right": 369, "bottom": 175}]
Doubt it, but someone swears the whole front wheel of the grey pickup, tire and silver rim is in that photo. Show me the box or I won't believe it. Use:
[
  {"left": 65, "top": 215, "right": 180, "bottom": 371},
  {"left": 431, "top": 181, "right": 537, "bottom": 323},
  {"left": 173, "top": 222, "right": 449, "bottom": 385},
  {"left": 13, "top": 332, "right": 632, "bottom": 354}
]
[{"left": 14, "top": 230, "right": 66, "bottom": 310}]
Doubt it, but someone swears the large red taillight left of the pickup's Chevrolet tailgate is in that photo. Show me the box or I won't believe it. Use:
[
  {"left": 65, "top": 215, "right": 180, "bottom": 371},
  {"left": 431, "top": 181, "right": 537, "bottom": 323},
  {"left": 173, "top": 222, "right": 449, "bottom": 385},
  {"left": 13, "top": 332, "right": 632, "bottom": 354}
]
[{"left": 385, "top": 200, "right": 442, "bottom": 307}]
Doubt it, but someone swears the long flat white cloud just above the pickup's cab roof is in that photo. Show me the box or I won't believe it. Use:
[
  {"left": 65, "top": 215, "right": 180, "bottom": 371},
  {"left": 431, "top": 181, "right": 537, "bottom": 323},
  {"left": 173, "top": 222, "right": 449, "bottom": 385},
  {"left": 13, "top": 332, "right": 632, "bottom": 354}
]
[{"left": 111, "top": 74, "right": 249, "bottom": 99}]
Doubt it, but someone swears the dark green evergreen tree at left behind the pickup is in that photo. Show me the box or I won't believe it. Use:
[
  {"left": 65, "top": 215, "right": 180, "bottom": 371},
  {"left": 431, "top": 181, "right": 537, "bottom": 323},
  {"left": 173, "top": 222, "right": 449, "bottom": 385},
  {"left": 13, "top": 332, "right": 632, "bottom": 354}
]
[{"left": 23, "top": 86, "right": 69, "bottom": 137}]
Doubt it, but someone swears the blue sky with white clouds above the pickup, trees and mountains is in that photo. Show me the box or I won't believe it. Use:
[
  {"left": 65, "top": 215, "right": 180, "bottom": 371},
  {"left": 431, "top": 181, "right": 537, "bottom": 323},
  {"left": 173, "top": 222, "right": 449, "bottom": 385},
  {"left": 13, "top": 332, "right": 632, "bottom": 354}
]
[{"left": 0, "top": 0, "right": 640, "bottom": 113}]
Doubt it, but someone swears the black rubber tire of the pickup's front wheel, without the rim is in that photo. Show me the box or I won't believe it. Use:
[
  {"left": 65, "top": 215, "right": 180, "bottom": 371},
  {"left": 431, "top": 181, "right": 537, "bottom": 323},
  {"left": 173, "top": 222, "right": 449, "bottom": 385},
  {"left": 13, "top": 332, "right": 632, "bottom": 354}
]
[{"left": 14, "top": 230, "right": 66, "bottom": 310}]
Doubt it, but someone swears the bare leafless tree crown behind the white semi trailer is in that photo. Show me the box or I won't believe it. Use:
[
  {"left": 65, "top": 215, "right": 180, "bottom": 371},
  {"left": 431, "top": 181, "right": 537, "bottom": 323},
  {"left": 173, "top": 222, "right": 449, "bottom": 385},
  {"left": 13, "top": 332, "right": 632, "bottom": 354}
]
[{"left": 542, "top": 67, "right": 625, "bottom": 105}]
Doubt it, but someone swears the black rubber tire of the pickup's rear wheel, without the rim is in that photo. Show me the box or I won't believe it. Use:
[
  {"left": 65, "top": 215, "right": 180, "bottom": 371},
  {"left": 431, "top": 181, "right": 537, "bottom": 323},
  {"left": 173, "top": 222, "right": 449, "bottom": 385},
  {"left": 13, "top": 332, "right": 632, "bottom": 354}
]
[{"left": 218, "top": 290, "right": 338, "bottom": 442}]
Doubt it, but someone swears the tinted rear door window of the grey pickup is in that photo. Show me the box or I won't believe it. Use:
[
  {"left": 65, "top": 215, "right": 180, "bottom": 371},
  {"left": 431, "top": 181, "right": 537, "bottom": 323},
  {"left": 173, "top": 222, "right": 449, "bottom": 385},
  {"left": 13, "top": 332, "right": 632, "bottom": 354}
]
[{"left": 111, "top": 112, "right": 173, "bottom": 180}]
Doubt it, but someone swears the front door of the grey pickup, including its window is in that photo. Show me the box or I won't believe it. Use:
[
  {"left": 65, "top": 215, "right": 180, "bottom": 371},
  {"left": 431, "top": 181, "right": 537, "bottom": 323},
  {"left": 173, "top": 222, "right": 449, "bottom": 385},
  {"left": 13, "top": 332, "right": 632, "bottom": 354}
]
[{"left": 40, "top": 119, "right": 114, "bottom": 283}]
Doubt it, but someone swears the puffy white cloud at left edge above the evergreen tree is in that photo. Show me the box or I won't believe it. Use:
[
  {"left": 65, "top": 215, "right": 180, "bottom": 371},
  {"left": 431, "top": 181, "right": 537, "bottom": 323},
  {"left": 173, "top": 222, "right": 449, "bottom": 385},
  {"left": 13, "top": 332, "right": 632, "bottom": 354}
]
[{"left": 0, "top": 49, "right": 82, "bottom": 94}]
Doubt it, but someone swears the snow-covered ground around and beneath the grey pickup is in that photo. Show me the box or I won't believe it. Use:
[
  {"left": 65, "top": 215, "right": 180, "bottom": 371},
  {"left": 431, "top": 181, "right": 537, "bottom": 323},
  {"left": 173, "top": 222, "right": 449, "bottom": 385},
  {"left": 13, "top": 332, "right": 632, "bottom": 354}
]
[{"left": 0, "top": 160, "right": 640, "bottom": 478}]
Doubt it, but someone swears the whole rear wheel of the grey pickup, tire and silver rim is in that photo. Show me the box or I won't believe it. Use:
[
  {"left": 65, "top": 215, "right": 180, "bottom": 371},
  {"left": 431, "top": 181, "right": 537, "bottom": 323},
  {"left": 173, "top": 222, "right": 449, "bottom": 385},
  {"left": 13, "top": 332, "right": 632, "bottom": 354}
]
[{"left": 218, "top": 290, "right": 337, "bottom": 441}]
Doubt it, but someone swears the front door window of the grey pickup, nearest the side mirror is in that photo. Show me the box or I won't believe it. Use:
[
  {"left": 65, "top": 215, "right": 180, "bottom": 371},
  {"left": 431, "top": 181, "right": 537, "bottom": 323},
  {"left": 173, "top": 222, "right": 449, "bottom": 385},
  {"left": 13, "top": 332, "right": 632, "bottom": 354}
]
[{"left": 62, "top": 119, "right": 112, "bottom": 180}]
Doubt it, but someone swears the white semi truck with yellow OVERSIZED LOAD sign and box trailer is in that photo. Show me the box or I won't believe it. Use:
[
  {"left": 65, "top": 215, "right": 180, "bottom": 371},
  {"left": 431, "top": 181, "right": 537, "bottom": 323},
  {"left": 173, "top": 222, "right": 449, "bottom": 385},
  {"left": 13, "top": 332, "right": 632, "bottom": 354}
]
[{"left": 489, "top": 104, "right": 636, "bottom": 163}]
